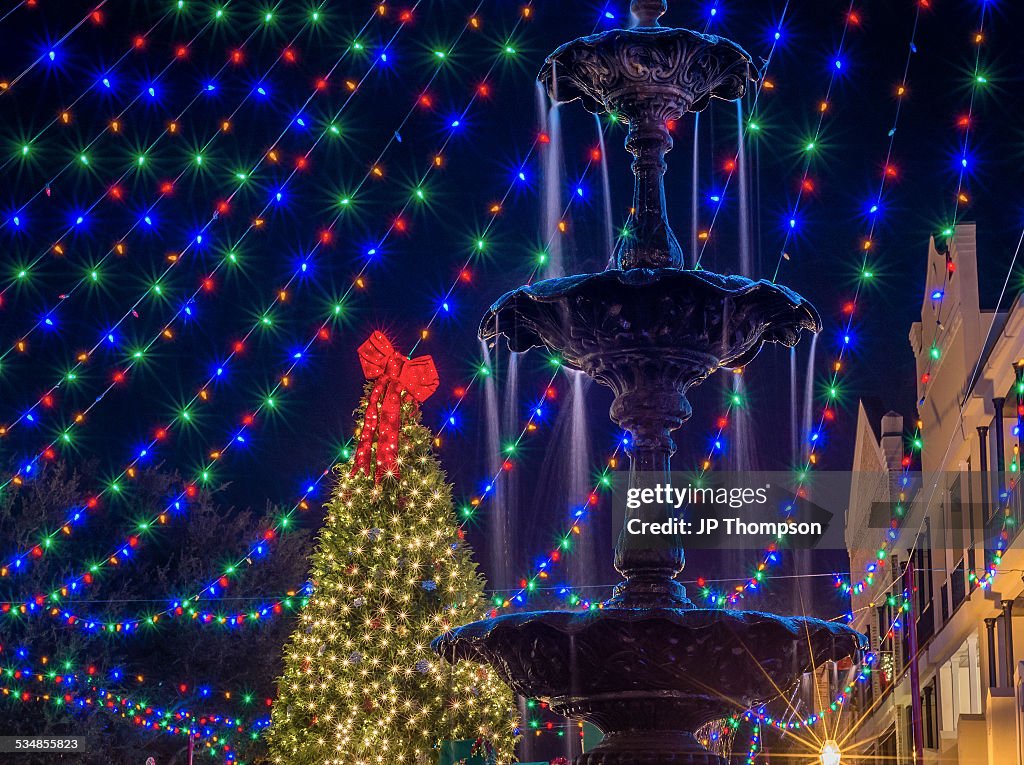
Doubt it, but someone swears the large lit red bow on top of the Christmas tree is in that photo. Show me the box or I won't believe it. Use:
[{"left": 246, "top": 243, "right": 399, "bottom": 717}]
[{"left": 351, "top": 332, "right": 439, "bottom": 483}]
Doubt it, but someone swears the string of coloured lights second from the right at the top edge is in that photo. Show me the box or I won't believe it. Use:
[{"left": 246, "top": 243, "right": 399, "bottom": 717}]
[{"left": 708, "top": 0, "right": 927, "bottom": 602}]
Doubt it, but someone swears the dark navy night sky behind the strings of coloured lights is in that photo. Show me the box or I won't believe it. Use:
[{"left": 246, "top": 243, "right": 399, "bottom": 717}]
[{"left": 0, "top": 0, "right": 1024, "bottom": 618}]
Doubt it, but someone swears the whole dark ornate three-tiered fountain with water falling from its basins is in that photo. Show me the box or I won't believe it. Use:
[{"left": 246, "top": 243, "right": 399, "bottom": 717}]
[{"left": 434, "top": 0, "right": 862, "bottom": 765}]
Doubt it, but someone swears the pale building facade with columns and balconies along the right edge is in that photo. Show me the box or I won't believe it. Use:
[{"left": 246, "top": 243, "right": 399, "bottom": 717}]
[{"left": 843, "top": 223, "right": 1024, "bottom": 765}]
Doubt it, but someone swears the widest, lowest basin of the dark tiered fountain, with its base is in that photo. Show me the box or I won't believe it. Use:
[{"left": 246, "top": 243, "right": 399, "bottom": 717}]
[{"left": 433, "top": 607, "right": 866, "bottom": 765}]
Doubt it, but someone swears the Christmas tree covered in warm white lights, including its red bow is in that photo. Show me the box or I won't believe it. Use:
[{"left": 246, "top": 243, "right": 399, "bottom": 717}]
[{"left": 269, "top": 333, "right": 517, "bottom": 765}]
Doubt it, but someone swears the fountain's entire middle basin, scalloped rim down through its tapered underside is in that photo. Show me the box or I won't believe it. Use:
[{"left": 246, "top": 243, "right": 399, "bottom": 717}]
[{"left": 480, "top": 268, "right": 821, "bottom": 435}]
